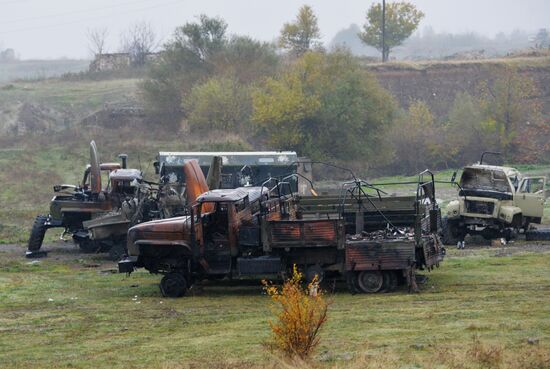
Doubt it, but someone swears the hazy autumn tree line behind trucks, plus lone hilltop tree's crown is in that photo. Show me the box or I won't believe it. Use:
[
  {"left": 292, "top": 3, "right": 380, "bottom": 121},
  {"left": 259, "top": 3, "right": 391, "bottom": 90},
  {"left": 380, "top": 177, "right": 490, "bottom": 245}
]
[{"left": 141, "top": 3, "right": 550, "bottom": 173}]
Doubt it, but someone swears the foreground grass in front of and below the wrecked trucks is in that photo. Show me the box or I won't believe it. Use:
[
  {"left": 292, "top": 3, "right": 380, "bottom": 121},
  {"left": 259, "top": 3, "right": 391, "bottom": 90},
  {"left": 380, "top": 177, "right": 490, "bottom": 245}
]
[{"left": 0, "top": 242, "right": 550, "bottom": 369}]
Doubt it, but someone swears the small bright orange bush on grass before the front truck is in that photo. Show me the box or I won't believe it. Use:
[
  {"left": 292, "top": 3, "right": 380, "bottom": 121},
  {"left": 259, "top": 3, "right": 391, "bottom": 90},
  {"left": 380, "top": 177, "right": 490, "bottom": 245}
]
[{"left": 263, "top": 266, "right": 328, "bottom": 359}]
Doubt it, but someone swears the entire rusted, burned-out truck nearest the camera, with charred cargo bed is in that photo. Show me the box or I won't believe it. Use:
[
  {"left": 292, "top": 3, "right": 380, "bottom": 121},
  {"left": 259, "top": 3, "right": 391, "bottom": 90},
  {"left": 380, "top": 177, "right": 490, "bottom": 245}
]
[{"left": 119, "top": 161, "right": 444, "bottom": 297}]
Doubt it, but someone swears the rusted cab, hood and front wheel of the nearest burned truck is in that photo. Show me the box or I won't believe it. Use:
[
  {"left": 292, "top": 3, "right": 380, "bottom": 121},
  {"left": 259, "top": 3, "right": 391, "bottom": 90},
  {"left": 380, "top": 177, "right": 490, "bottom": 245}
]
[{"left": 119, "top": 187, "right": 280, "bottom": 297}]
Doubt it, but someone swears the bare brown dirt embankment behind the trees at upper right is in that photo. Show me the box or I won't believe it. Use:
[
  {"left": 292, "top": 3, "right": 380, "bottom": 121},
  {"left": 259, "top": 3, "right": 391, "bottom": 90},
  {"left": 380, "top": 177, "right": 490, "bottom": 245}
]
[{"left": 369, "top": 57, "right": 550, "bottom": 118}]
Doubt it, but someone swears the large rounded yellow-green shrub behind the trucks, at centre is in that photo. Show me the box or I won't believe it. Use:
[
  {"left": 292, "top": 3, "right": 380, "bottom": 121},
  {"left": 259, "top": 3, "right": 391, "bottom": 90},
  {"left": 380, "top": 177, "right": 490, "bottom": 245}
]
[{"left": 252, "top": 50, "right": 396, "bottom": 166}]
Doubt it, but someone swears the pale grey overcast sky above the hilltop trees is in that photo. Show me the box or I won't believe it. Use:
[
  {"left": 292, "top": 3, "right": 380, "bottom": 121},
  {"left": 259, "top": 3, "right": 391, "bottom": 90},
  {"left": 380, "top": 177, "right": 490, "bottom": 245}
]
[{"left": 0, "top": 0, "right": 550, "bottom": 59}]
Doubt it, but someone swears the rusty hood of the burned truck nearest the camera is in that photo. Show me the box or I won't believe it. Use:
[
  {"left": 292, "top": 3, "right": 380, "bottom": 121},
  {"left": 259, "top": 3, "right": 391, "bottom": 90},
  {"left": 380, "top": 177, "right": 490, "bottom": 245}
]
[{"left": 127, "top": 216, "right": 191, "bottom": 256}]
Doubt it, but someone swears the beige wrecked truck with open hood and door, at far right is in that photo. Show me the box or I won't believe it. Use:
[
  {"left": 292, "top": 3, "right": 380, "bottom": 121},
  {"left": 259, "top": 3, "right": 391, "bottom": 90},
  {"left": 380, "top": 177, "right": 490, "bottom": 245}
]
[{"left": 442, "top": 153, "right": 546, "bottom": 248}]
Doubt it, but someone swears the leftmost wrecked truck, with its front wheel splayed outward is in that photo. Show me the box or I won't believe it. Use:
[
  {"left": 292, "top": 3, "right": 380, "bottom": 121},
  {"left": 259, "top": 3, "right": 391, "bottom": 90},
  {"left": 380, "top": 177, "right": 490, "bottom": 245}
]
[{"left": 26, "top": 141, "right": 141, "bottom": 257}]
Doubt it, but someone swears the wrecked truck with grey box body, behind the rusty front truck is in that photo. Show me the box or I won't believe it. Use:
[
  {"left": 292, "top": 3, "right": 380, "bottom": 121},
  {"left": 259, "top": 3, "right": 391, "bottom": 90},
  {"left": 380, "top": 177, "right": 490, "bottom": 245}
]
[{"left": 82, "top": 152, "right": 306, "bottom": 261}]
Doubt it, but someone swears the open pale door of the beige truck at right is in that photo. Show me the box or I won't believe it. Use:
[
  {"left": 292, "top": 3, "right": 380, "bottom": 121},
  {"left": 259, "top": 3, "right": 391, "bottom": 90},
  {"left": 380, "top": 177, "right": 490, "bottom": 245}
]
[{"left": 514, "top": 177, "right": 546, "bottom": 218}]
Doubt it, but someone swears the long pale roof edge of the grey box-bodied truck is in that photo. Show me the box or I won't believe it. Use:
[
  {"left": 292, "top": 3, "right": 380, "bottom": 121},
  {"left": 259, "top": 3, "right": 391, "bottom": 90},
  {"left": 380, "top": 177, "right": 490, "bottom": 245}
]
[{"left": 158, "top": 151, "right": 298, "bottom": 166}]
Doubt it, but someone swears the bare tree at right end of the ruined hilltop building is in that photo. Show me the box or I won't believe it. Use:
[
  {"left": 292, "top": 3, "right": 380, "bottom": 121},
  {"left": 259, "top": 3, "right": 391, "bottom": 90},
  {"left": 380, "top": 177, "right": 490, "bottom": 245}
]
[{"left": 120, "top": 21, "right": 158, "bottom": 66}]
